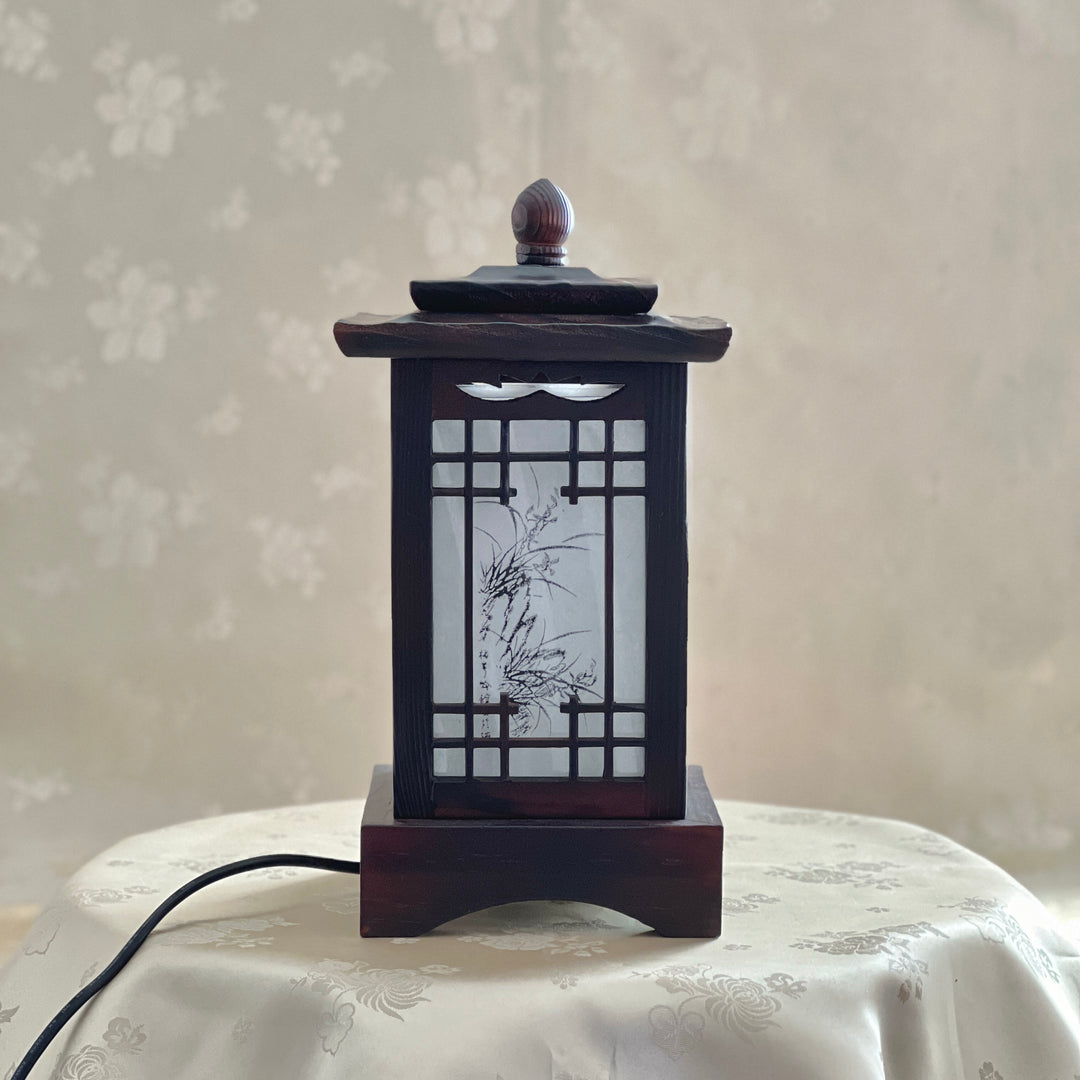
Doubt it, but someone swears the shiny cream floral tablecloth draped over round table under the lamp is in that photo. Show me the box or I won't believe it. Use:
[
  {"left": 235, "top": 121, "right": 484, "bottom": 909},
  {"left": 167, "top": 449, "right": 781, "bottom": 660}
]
[{"left": 0, "top": 801, "right": 1080, "bottom": 1080}]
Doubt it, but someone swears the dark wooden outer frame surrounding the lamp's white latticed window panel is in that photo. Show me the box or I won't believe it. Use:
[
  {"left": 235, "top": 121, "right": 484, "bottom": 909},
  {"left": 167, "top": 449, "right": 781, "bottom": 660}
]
[{"left": 391, "top": 359, "right": 687, "bottom": 819}]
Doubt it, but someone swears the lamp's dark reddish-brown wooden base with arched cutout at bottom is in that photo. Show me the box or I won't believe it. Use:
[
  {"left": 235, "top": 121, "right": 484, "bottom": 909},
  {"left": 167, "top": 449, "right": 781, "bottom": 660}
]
[{"left": 360, "top": 765, "right": 724, "bottom": 937}]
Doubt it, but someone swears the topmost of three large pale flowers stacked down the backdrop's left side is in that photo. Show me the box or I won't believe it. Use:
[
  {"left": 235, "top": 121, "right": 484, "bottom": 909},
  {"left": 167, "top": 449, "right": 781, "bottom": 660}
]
[{"left": 94, "top": 41, "right": 225, "bottom": 164}]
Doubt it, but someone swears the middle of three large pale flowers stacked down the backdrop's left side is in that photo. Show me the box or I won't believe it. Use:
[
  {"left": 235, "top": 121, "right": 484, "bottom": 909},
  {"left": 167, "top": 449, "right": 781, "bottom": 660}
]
[{"left": 85, "top": 249, "right": 179, "bottom": 364}]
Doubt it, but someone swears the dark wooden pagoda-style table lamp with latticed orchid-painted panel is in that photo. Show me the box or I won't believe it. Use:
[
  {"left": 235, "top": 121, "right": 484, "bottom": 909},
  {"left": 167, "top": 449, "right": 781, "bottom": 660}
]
[{"left": 334, "top": 179, "right": 731, "bottom": 936}]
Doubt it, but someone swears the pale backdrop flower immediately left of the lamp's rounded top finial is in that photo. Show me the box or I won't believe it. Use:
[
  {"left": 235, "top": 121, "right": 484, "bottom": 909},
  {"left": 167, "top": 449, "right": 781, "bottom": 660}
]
[{"left": 416, "top": 161, "right": 505, "bottom": 266}]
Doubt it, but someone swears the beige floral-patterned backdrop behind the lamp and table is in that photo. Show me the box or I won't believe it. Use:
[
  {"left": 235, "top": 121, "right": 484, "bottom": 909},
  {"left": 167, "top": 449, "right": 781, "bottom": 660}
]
[{"left": 0, "top": 0, "right": 1080, "bottom": 903}]
